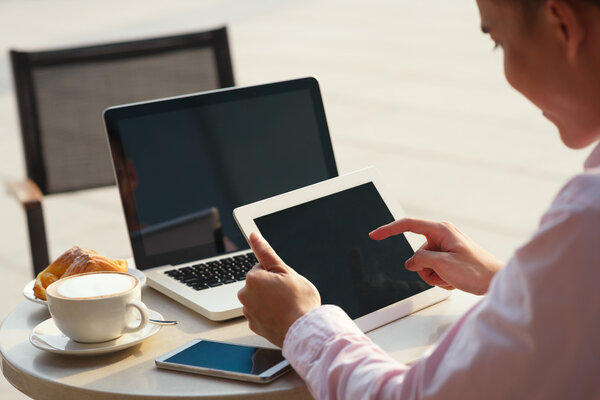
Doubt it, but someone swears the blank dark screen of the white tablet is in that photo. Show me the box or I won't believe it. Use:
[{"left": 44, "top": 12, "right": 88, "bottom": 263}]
[{"left": 254, "top": 182, "right": 431, "bottom": 319}]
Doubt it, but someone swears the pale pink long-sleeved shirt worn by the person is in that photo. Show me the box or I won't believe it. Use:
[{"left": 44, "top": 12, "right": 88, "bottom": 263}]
[{"left": 283, "top": 145, "right": 600, "bottom": 400}]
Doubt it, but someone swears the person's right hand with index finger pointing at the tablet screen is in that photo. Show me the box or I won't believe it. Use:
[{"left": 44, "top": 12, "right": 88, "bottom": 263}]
[{"left": 369, "top": 218, "right": 504, "bottom": 294}]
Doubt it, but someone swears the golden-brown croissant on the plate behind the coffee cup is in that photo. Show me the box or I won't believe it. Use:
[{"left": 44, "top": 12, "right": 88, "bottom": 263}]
[{"left": 33, "top": 246, "right": 127, "bottom": 300}]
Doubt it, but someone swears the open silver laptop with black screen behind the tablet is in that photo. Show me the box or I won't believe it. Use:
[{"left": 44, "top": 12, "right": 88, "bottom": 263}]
[{"left": 104, "top": 78, "right": 338, "bottom": 321}]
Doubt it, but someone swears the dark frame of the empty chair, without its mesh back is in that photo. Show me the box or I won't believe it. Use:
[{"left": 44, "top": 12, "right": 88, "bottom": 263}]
[{"left": 7, "top": 27, "right": 234, "bottom": 275}]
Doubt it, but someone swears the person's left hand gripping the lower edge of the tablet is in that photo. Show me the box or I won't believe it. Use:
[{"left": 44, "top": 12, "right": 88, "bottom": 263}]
[{"left": 238, "top": 232, "right": 321, "bottom": 347}]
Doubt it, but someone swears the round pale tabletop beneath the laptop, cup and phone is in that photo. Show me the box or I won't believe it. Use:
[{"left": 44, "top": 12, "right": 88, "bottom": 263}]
[{"left": 0, "top": 287, "right": 479, "bottom": 400}]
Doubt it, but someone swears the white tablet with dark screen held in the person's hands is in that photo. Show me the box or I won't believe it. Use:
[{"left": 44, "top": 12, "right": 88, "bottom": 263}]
[{"left": 233, "top": 167, "right": 450, "bottom": 332}]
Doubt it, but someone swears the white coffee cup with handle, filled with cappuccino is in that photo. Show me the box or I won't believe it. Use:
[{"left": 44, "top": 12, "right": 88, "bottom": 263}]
[{"left": 46, "top": 272, "right": 148, "bottom": 343}]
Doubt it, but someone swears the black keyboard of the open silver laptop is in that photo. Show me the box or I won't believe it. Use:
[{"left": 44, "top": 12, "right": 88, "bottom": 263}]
[{"left": 164, "top": 252, "right": 258, "bottom": 290}]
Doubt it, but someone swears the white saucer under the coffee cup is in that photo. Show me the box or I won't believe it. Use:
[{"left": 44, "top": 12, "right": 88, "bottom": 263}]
[{"left": 29, "top": 310, "right": 163, "bottom": 356}]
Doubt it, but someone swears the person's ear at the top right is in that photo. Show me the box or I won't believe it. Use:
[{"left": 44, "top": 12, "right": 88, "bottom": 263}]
[{"left": 544, "top": 0, "right": 585, "bottom": 63}]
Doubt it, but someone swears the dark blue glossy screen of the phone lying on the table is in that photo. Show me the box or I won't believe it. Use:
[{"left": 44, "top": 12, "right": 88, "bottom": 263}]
[{"left": 163, "top": 340, "right": 284, "bottom": 375}]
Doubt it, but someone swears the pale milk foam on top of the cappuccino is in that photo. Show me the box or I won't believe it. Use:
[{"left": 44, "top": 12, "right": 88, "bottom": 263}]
[{"left": 54, "top": 273, "right": 137, "bottom": 299}]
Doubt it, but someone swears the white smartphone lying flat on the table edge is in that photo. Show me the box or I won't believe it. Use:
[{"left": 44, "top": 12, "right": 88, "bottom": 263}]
[{"left": 155, "top": 339, "right": 291, "bottom": 383}]
